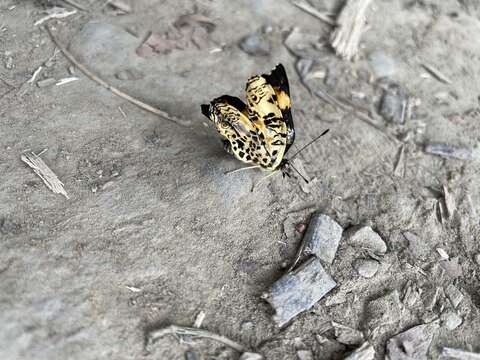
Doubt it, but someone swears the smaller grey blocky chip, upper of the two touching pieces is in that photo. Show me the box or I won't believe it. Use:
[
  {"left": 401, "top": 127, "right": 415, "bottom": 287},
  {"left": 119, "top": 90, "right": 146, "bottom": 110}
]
[{"left": 303, "top": 213, "right": 343, "bottom": 264}]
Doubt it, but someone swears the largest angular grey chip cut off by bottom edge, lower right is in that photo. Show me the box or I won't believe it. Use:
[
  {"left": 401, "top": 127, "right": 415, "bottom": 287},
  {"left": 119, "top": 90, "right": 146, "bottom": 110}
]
[{"left": 386, "top": 323, "right": 439, "bottom": 360}]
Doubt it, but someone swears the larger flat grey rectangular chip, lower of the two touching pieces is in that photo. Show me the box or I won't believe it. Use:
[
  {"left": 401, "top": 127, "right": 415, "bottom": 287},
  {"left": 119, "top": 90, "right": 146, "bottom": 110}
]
[{"left": 262, "top": 257, "right": 336, "bottom": 327}]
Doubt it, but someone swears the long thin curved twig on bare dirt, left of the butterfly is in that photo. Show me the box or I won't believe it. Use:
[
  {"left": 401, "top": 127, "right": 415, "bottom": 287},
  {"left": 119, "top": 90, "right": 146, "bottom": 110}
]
[{"left": 46, "top": 26, "right": 189, "bottom": 126}]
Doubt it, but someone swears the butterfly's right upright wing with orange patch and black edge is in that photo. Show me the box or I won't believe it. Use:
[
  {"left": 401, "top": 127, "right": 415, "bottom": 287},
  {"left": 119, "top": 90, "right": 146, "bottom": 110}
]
[{"left": 246, "top": 64, "right": 295, "bottom": 170}]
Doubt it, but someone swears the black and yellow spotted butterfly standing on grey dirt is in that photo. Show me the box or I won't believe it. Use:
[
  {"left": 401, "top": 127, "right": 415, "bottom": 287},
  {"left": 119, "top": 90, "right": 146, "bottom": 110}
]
[{"left": 201, "top": 64, "right": 328, "bottom": 181}]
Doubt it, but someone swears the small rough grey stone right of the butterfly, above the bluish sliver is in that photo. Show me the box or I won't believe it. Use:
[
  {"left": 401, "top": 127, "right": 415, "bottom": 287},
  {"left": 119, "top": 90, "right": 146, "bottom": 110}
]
[{"left": 379, "top": 84, "right": 409, "bottom": 124}]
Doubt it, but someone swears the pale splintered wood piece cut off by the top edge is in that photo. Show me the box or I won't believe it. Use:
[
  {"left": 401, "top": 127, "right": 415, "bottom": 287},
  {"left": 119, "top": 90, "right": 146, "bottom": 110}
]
[{"left": 330, "top": 0, "right": 372, "bottom": 60}]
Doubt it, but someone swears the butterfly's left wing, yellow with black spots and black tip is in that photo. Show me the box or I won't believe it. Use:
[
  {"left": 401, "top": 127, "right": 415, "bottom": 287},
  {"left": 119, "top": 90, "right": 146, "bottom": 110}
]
[{"left": 202, "top": 95, "right": 269, "bottom": 167}]
